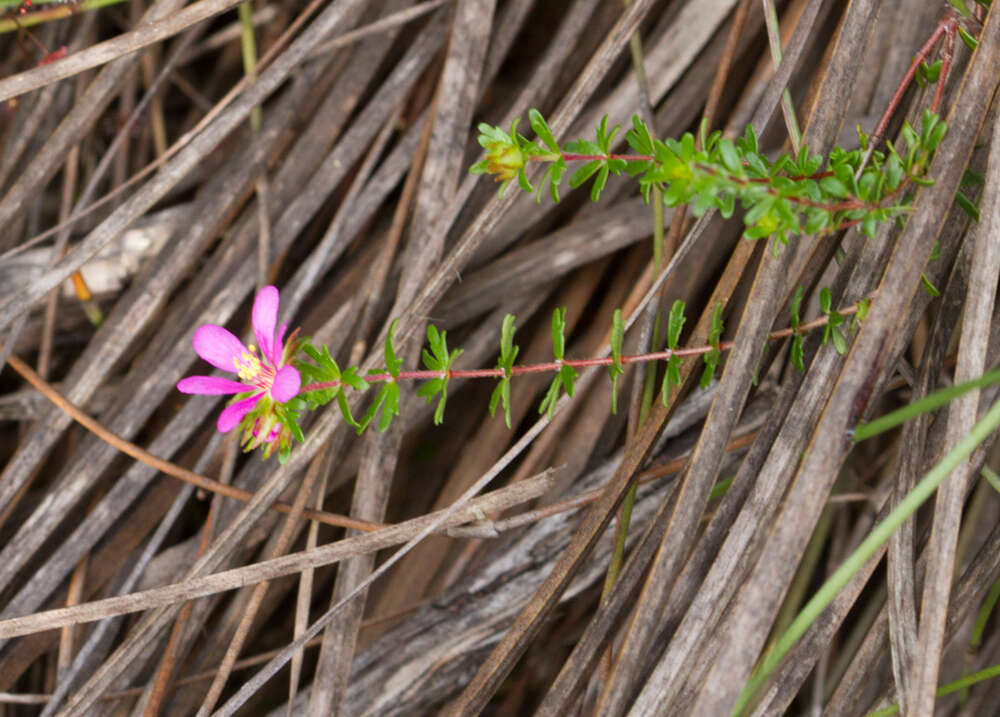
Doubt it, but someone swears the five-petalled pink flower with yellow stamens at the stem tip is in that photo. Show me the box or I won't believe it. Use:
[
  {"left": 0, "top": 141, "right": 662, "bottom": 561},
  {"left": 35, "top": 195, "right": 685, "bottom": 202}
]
[{"left": 177, "top": 286, "right": 302, "bottom": 442}]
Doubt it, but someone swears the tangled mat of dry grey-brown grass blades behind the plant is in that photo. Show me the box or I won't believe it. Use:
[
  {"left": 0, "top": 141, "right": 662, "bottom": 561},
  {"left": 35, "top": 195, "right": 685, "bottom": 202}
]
[{"left": 0, "top": 0, "right": 1000, "bottom": 715}]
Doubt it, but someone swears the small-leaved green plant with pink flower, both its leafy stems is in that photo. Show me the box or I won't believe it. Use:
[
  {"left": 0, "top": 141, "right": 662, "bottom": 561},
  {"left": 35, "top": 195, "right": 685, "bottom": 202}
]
[{"left": 177, "top": 88, "right": 960, "bottom": 462}]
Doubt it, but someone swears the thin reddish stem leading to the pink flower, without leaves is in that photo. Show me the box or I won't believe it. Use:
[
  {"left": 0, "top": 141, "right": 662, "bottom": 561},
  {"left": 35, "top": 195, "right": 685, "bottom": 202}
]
[{"left": 300, "top": 304, "right": 858, "bottom": 393}]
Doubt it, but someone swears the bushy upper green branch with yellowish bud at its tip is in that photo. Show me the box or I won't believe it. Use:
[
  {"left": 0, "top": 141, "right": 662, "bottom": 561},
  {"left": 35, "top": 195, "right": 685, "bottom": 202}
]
[{"left": 470, "top": 107, "right": 947, "bottom": 249}]
